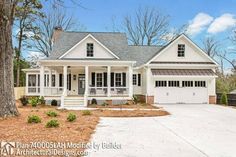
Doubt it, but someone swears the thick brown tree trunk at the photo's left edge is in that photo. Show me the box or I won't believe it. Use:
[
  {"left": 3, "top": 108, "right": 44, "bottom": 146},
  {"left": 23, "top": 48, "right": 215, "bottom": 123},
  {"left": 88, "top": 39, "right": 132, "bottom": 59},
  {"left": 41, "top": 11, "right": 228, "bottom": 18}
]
[{"left": 0, "top": 0, "right": 19, "bottom": 117}]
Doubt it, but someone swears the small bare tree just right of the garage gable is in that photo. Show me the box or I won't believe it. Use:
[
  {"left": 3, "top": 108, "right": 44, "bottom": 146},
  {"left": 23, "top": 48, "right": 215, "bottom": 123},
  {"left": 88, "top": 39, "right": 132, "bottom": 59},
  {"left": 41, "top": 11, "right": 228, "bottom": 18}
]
[{"left": 202, "top": 37, "right": 219, "bottom": 57}]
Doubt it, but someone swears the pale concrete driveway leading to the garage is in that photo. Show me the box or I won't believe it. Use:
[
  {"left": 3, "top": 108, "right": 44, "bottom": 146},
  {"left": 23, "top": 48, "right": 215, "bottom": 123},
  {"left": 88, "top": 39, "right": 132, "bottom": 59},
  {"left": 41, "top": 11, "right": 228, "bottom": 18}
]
[{"left": 85, "top": 104, "right": 236, "bottom": 157}]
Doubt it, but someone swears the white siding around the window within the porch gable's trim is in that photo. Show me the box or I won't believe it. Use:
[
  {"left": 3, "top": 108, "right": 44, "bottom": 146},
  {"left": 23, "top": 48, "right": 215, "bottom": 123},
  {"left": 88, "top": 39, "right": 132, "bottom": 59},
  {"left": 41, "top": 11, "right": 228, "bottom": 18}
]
[{"left": 63, "top": 37, "right": 114, "bottom": 59}]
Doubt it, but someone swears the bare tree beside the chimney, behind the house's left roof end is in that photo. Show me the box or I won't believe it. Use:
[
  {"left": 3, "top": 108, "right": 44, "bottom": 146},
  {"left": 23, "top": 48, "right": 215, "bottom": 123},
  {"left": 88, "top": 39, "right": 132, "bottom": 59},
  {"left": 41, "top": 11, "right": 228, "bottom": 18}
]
[{"left": 32, "top": 7, "right": 85, "bottom": 57}]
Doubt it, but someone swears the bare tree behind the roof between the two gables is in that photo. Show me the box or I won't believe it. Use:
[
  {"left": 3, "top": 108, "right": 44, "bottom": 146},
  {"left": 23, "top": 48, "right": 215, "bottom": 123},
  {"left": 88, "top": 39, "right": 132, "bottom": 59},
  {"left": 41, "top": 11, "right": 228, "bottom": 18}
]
[{"left": 123, "top": 7, "right": 169, "bottom": 45}]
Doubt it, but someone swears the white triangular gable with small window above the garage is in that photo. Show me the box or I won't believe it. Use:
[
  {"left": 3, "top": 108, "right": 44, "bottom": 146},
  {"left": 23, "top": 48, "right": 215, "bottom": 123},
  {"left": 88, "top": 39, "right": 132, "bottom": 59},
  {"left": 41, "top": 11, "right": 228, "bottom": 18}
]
[{"left": 148, "top": 35, "right": 215, "bottom": 63}]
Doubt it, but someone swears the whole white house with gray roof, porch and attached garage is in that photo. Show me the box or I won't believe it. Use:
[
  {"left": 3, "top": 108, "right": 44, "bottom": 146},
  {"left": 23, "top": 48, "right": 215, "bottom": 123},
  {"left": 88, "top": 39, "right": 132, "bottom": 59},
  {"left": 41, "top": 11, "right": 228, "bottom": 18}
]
[{"left": 24, "top": 29, "right": 217, "bottom": 108}]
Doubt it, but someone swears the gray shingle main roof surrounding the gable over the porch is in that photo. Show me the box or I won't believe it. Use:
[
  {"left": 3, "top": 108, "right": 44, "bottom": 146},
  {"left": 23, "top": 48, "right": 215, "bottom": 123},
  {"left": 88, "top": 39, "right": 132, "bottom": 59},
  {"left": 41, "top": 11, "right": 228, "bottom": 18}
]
[{"left": 46, "top": 32, "right": 161, "bottom": 66}]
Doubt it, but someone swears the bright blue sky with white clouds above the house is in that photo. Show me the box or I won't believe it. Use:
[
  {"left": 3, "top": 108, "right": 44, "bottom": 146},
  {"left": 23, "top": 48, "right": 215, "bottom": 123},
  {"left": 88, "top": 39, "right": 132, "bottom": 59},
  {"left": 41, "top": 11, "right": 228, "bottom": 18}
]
[{"left": 28, "top": 0, "right": 236, "bottom": 70}]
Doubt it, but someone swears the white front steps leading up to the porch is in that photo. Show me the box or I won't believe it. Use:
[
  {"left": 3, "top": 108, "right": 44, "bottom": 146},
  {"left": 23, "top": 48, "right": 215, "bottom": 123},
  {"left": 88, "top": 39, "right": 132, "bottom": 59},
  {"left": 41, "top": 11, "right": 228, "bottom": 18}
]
[{"left": 64, "top": 97, "right": 85, "bottom": 107}]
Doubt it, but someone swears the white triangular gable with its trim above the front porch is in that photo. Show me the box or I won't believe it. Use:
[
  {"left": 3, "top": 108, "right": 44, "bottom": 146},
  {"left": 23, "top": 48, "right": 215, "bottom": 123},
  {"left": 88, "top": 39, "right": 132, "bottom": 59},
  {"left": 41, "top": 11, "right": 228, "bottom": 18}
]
[{"left": 60, "top": 35, "right": 117, "bottom": 59}]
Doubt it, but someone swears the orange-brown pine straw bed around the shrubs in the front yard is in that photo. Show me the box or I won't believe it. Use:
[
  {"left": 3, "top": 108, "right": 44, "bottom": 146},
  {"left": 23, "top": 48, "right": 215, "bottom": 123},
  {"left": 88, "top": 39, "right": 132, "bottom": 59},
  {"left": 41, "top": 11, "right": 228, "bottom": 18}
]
[{"left": 0, "top": 101, "right": 169, "bottom": 156}]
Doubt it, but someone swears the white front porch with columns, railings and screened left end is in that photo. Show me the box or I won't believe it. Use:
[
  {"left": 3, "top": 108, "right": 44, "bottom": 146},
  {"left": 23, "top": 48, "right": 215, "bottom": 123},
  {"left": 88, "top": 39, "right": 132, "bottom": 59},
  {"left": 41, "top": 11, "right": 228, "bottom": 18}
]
[{"left": 26, "top": 60, "right": 133, "bottom": 107}]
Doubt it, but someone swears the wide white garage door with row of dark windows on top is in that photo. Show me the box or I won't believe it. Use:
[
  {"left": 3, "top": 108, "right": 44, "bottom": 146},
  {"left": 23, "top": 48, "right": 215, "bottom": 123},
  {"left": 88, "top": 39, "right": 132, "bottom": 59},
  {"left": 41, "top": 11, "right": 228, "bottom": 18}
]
[{"left": 154, "top": 81, "right": 208, "bottom": 104}]
